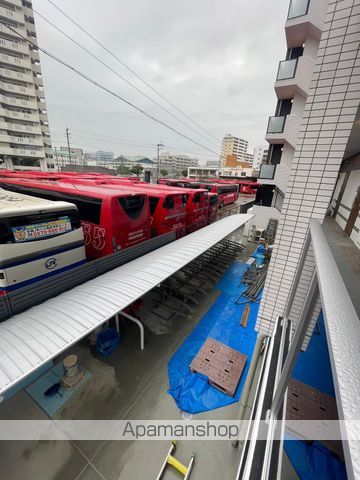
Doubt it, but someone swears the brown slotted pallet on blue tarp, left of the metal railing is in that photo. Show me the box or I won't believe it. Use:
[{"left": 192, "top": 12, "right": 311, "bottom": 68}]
[{"left": 190, "top": 338, "right": 247, "bottom": 397}]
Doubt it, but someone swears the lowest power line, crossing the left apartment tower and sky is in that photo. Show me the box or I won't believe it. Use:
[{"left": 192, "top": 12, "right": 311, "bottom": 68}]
[{"left": 0, "top": 21, "right": 218, "bottom": 155}]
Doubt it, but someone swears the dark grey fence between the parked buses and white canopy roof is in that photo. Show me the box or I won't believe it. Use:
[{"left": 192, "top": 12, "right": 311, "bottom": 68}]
[{"left": 0, "top": 233, "right": 176, "bottom": 321}]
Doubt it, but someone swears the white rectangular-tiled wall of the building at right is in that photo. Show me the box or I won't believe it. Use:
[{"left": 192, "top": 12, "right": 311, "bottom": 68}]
[{"left": 257, "top": 0, "right": 360, "bottom": 344}]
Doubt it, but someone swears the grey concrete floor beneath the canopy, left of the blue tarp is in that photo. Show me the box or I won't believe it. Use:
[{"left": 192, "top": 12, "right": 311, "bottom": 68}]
[{"left": 0, "top": 242, "right": 262, "bottom": 480}]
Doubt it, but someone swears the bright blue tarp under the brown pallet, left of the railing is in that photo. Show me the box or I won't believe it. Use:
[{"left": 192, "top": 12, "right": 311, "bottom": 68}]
[{"left": 168, "top": 262, "right": 259, "bottom": 413}]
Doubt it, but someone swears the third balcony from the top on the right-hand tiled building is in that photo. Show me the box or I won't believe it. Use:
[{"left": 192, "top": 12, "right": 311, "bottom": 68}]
[{"left": 265, "top": 114, "right": 301, "bottom": 148}]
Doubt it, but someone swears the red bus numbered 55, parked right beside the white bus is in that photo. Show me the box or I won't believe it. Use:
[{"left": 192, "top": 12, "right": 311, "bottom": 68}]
[{"left": 0, "top": 178, "right": 150, "bottom": 260}]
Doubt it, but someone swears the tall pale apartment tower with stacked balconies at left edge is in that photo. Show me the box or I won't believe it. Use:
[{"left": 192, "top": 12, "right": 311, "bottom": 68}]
[{"left": 0, "top": 0, "right": 54, "bottom": 170}]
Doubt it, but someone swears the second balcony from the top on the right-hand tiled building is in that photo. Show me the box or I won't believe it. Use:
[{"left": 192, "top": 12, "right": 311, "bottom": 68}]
[{"left": 275, "top": 55, "right": 315, "bottom": 99}]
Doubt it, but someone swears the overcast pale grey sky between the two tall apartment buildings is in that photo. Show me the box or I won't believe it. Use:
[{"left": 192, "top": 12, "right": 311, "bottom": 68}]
[{"left": 33, "top": 0, "right": 288, "bottom": 162}]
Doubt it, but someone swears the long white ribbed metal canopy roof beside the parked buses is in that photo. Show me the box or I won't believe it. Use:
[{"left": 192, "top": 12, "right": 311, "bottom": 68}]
[{"left": 0, "top": 214, "right": 252, "bottom": 395}]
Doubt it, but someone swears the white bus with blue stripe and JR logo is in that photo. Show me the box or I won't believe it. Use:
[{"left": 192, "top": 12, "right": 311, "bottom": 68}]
[{"left": 0, "top": 188, "right": 85, "bottom": 295}]
